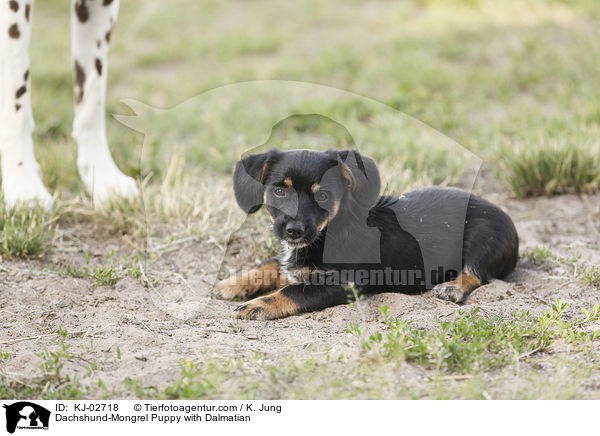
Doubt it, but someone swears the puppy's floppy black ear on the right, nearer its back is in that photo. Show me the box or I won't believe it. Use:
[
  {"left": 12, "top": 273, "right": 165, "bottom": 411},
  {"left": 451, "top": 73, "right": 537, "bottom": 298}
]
[{"left": 327, "top": 150, "right": 381, "bottom": 208}]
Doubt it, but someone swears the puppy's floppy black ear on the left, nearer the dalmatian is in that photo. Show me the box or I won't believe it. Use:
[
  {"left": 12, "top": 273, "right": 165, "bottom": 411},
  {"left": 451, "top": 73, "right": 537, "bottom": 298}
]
[{"left": 233, "top": 148, "right": 279, "bottom": 213}]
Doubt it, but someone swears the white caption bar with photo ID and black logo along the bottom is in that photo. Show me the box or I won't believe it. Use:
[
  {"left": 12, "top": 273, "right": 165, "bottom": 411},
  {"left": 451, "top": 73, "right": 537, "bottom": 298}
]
[{"left": 0, "top": 400, "right": 599, "bottom": 436}]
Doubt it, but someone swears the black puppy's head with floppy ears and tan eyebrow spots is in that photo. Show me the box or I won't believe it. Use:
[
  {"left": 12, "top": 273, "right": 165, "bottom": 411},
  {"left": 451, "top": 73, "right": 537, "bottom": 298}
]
[{"left": 233, "top": 149, "right": 381, "bottom": 247}]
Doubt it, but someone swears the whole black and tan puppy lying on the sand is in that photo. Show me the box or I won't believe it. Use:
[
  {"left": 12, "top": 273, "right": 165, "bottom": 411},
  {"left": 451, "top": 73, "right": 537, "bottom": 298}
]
[{"left": 214, "top": 149, "right": 518, "bottom": 319}]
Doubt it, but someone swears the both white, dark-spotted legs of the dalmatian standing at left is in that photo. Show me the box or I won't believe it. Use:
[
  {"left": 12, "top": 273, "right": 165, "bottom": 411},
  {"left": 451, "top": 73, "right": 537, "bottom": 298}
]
[{"left": 0, "top": 0, "right": 138, "bottom": 206}]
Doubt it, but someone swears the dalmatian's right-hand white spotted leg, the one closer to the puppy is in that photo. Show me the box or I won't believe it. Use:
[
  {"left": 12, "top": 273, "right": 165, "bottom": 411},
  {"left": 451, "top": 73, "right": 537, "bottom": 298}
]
[{"left": 71, "top": 0, "right": 138, "bottom": 203}]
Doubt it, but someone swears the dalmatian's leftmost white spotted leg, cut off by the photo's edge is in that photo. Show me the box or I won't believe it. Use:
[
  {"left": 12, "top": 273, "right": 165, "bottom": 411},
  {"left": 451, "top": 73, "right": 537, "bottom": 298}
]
[{"left": 0, "top": 0, "right": 51, "bottom": 206}]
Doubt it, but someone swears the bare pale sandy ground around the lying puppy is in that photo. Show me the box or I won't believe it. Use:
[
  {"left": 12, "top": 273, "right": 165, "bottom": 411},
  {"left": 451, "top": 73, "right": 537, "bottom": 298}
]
[{"left": 0, "top": 180, "right": 600, "bottom": 396}]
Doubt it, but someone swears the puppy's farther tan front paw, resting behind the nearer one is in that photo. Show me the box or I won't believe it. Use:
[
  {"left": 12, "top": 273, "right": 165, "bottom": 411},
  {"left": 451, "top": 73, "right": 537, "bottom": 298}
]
[{"left": 213, "top": 262, "right": 287, "bottom": 300}]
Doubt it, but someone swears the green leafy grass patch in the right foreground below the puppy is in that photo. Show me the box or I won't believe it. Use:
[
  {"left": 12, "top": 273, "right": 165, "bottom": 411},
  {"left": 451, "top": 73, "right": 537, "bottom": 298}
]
[{"left": 349, "top": 300, "right": 600, "bottom": 373}]
